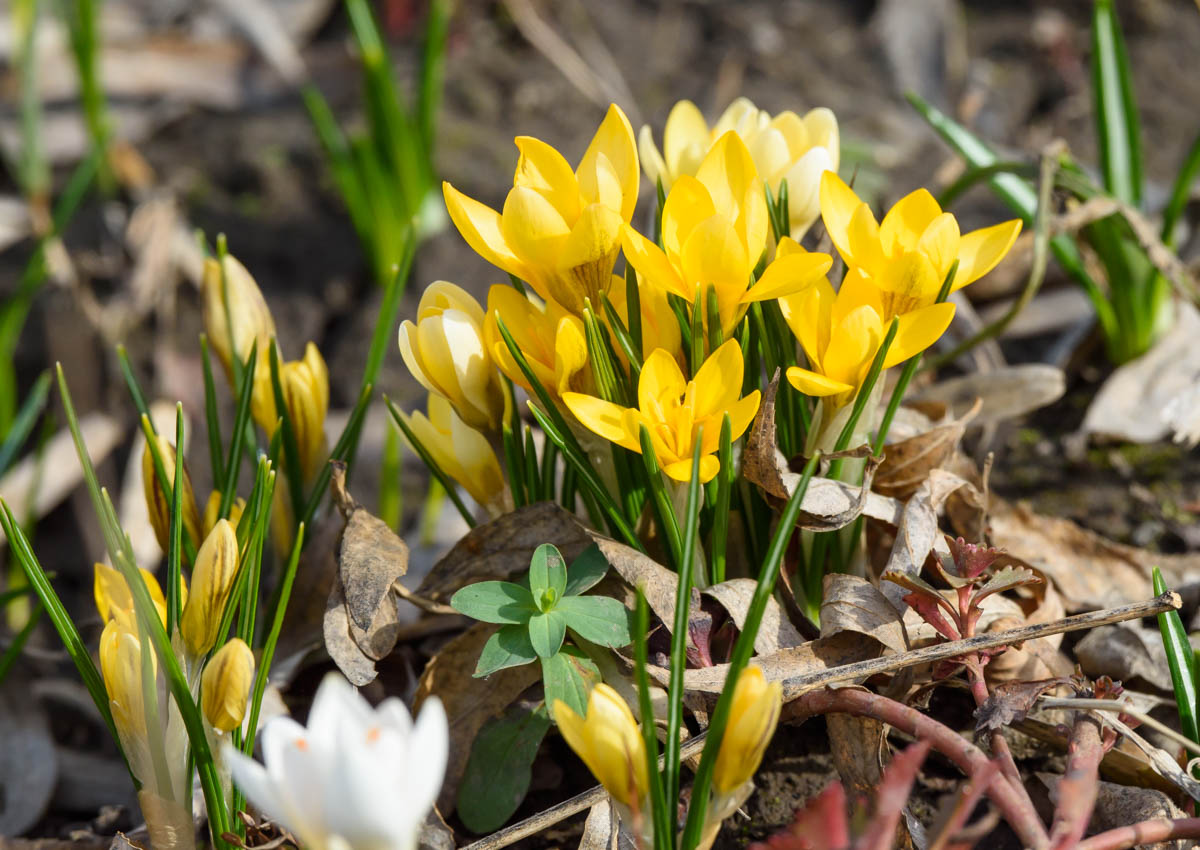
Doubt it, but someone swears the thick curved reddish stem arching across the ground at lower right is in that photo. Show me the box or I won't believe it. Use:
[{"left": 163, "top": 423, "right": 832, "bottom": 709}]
[{"left": 785, "top": 688, "right": 1050, "bottom": 850}]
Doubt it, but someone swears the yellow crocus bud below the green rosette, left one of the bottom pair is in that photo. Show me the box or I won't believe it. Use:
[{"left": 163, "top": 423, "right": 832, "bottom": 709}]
[{"left": 554, "top": 682, "right": 649, "bottom": 809}]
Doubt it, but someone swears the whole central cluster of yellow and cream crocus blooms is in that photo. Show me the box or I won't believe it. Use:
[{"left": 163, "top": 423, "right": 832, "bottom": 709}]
[{"left": 400, "top": 98, "right": 1020, "bottom": 501}]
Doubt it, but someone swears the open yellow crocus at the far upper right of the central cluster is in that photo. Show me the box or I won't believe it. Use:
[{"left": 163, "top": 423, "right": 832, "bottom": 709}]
[{"left": 821, "top": 173, "right": 1021, "bottom": 322}]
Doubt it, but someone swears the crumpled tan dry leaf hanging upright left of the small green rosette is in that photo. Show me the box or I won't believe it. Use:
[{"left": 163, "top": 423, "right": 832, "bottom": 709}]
[{"left": 330, "top": 463, "right": 408, "bottom": 629}]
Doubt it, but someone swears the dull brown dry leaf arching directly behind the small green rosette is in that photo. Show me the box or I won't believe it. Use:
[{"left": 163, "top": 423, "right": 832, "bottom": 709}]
[{"left": 416, "top": 502, "right": 593, "bottom": 601}]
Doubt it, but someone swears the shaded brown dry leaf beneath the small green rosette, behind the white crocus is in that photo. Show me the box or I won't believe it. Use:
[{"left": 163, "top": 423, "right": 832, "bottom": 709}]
[{"left": 414, "top": 623, "right": 541, "bottom": 818}]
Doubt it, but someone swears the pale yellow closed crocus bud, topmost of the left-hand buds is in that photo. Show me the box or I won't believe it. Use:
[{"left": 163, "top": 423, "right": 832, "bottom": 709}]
[{"left": 200, "top": 255, "right": 275, "bottom": 376}]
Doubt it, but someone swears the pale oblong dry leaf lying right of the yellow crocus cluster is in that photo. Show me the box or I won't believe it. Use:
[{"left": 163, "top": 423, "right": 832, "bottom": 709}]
[{"left": 913, "top": 363, "right": 1067, "bottom": 426}]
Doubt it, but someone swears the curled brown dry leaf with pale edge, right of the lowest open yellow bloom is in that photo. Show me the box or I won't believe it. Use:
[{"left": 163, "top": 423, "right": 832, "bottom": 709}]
[{"left": 742, "top": 372, "right": 900, "bottom": 532}]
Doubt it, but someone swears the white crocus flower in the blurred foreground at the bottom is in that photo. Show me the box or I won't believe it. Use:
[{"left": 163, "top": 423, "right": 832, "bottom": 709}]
[{"left": 224, "top": 674, "right": 450, "bottom": 850}]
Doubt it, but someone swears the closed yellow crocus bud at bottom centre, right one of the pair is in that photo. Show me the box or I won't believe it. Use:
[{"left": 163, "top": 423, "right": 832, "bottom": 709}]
[{"left": 713, "top": 666, "right": 784, "bottom": 794}]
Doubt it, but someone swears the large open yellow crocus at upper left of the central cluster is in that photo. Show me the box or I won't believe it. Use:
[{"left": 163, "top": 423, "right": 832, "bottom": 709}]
[{"left": 443, "top": 104, "right": 640, "bottom": 315}]
